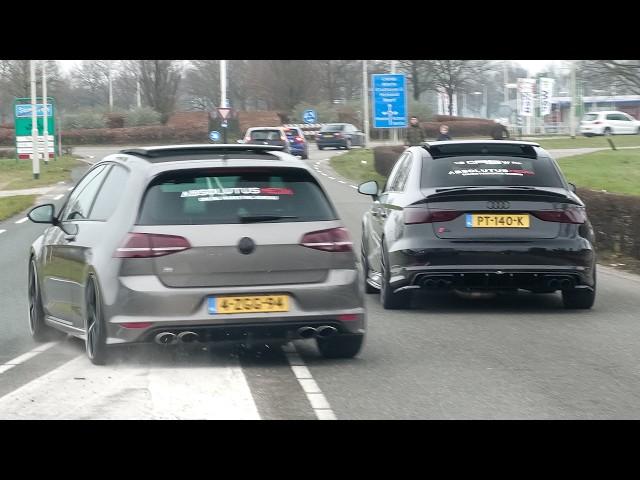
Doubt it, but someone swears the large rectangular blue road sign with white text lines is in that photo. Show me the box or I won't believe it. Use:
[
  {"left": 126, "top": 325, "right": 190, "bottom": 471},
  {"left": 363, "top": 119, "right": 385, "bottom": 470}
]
[{"left": 371, "top": 73, "right": 407, "bottom": 128}]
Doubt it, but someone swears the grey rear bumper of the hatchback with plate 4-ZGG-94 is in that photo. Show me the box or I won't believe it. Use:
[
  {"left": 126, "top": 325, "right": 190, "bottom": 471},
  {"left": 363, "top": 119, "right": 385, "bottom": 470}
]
[{"left": 104, "top": 270, "right": 365, "bottom": 344}]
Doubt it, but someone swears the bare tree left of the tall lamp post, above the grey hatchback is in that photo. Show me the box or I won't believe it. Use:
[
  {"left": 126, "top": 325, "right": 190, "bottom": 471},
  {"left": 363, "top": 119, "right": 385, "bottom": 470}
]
[{"left": 138, "top": 60, "right": 182, "bottom": 124}]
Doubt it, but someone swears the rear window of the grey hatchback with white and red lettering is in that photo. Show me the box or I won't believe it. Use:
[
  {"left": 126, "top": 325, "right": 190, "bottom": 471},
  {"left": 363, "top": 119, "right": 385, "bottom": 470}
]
[{"left": 138, "top": 168, "right": 337, "bottom": 225}]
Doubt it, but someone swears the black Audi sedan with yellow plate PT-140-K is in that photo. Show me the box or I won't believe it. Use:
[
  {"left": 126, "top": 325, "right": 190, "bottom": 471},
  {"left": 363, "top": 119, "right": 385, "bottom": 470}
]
[{"left": 359, "top": 140, "right": 596, "bottom": 309}]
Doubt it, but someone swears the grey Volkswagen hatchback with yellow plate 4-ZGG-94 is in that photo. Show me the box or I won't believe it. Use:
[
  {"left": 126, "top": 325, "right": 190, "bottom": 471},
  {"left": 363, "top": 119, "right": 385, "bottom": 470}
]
[{"left": 28, "top": 145, "right": 365, "bottom": 364}]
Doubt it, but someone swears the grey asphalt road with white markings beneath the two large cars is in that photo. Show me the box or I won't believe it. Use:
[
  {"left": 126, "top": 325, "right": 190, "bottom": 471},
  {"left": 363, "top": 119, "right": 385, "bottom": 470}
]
[{"left": 0, "top": 147, "right": 640, "bottom": 419}]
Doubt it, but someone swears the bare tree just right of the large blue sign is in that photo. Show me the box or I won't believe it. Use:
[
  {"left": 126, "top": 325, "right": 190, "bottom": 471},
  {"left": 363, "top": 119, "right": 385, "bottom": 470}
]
[{"left": 429, "top": 60, "right": 493, "bottom": 115}]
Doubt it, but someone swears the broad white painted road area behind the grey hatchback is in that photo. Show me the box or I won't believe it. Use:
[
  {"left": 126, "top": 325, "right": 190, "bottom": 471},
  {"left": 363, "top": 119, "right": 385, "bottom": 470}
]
[{"left": 0, "top": 352, "right": 260, "bottom": 420}]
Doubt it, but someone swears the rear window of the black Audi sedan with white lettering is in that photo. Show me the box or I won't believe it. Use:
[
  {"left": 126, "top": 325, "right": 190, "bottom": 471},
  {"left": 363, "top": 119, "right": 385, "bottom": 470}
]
[{"left": 422, "top": 156, "right": 564, "bottom": 188}]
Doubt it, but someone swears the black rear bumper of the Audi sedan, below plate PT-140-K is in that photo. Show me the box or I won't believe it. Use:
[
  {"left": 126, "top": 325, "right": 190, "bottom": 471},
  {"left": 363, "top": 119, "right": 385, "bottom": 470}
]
[{"left": 389, "top": 239, "right": 595, "bottom": 290}]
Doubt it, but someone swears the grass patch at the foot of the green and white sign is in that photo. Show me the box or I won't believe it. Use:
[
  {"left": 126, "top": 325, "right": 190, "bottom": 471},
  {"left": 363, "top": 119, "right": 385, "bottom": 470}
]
[{"left": 0, "top": 156, "right": 86, "bottom": 190}]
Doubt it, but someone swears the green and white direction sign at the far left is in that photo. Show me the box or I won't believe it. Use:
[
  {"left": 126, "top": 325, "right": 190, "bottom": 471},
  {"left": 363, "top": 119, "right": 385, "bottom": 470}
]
[{"left": 13, "top": 97, "right": 59, "bottom": 159}]
